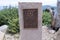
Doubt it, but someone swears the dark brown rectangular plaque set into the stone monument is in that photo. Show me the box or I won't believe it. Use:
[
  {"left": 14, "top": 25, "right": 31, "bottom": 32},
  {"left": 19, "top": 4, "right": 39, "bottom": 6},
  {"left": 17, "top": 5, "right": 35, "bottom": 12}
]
[{"left": 23, "top": 9, "right": 38, "bottom": 28}]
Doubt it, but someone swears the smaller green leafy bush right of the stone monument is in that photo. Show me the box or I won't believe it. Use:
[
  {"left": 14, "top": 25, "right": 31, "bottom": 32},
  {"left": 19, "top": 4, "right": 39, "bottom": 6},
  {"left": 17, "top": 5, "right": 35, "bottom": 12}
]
[{"left": 42, "top": 11, "right": 51, "bottom": 25}]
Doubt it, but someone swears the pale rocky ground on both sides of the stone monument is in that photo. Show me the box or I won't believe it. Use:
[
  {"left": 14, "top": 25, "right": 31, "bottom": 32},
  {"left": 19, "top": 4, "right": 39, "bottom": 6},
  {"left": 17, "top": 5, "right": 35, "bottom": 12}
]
[{"left": 4, "top": 26, "right": 58, "bottom": 40}]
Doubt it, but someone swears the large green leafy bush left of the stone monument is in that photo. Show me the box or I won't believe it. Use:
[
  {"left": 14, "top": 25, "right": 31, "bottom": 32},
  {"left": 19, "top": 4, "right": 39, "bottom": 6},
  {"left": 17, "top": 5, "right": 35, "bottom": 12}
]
[{"left": 0, "top": 7, "right": 19, "bottom": 34}]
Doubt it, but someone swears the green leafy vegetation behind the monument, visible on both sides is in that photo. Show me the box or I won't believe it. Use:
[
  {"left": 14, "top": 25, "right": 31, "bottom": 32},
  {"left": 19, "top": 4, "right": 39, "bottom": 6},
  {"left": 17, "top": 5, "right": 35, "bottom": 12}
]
[{"left": 0, "top": 7, "right": 51, "bottom": 34}]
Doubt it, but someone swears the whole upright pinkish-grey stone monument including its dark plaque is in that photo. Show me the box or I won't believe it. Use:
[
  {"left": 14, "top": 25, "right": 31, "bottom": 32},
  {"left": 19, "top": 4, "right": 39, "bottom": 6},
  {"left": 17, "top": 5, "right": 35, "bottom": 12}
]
[{"left": 19, "top": 2, "right": 42, "bottom": 40}]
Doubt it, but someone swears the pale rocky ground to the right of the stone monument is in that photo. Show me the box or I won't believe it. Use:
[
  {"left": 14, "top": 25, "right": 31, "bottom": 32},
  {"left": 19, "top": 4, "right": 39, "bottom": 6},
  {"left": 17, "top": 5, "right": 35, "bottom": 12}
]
[{"left": 42, "top": 26, "right": 57, "bottom": 40}]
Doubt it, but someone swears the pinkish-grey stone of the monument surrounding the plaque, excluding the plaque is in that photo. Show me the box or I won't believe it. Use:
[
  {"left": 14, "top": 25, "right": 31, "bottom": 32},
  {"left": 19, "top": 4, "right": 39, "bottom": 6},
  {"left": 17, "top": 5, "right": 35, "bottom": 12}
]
[{"left": 19, "top": 2, "right": 42, "bottom": 40}]
